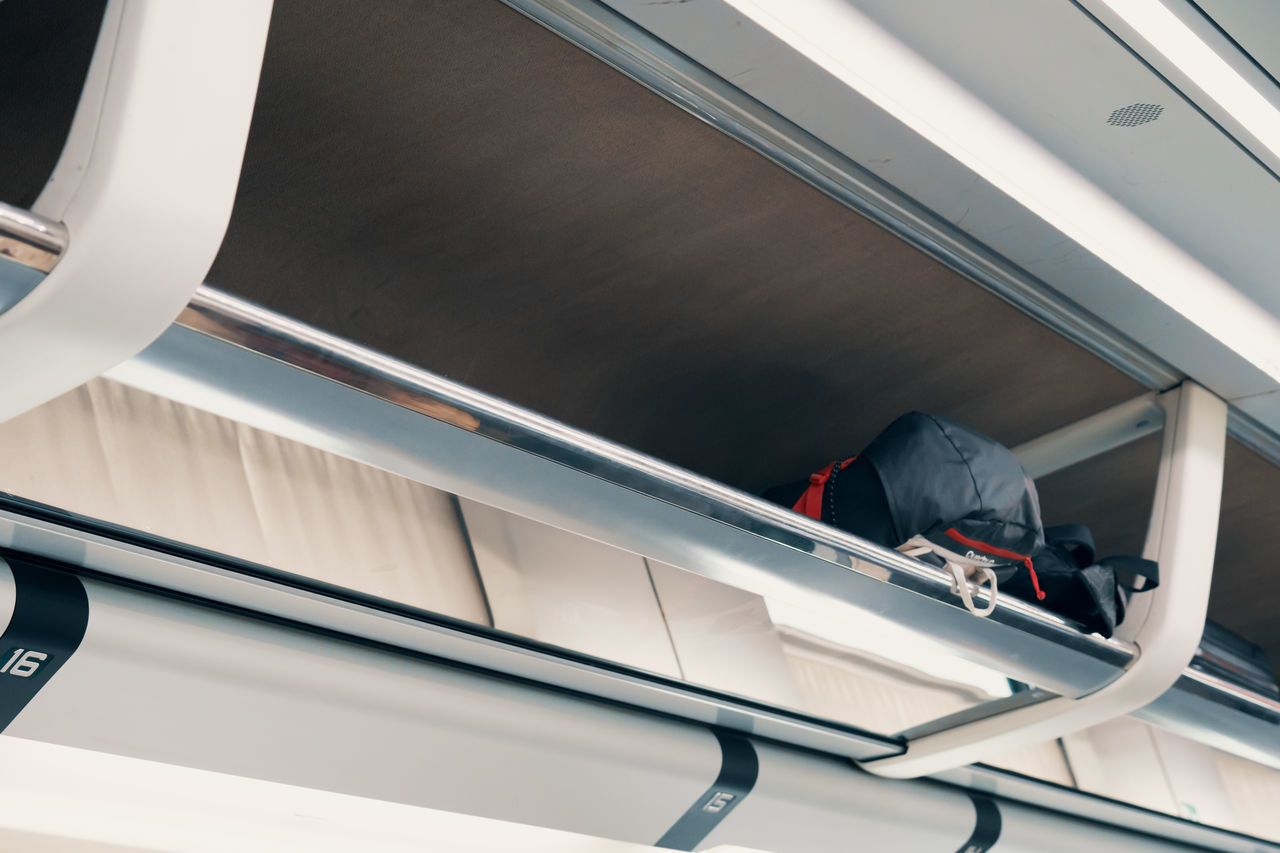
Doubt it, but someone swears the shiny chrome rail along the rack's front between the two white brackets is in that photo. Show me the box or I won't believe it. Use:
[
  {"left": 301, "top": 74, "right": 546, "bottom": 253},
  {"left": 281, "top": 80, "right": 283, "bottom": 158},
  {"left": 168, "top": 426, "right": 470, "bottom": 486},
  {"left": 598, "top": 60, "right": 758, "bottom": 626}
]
[{"left": 177, "top": 287, "right": 1134, "bottom": 671}]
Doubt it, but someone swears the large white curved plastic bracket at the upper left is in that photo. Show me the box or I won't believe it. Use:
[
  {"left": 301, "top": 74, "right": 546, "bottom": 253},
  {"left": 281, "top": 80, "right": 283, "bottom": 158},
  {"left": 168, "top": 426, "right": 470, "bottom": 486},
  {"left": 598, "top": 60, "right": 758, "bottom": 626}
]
[{"left": 0, "top": 0, "right": 271, "bottom": 420}]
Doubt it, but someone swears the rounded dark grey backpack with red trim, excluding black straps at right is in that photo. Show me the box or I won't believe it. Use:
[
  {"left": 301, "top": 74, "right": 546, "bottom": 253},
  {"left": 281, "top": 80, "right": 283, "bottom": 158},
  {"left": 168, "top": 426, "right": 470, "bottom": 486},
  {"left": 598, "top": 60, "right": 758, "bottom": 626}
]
[{"left": 763, "top": 411, "right": 1044, "bottom": 616}]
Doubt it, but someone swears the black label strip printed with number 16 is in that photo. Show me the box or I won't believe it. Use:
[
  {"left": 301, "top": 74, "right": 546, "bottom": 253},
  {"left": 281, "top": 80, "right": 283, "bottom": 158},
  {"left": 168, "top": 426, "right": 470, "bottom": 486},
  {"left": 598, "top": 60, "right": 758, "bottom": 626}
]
[{"left": 0, "top": 557, "right": 88, "bottom": 731}]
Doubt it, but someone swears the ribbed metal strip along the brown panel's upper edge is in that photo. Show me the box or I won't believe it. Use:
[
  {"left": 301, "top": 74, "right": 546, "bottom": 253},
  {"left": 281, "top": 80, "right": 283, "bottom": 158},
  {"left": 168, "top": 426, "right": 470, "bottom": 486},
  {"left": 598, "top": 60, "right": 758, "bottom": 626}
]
[{"left": 503, "top": 0, "right": 1183, "bottom": 389}]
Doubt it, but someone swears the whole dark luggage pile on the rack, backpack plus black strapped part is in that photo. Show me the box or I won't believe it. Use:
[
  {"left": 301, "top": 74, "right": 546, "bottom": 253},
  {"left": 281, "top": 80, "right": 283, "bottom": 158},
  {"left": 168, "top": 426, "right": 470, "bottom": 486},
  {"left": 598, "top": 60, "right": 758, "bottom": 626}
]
[{"left": 763, "top": 411, "right": 1167, "bottom": 630}]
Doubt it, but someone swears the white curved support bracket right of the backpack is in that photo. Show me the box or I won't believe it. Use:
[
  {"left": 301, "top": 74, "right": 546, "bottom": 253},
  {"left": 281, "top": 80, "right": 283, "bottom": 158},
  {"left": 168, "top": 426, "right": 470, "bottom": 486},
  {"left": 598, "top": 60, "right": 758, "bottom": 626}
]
[{"left": 861, "top": 382, "right": 1226, "bottom": 779}]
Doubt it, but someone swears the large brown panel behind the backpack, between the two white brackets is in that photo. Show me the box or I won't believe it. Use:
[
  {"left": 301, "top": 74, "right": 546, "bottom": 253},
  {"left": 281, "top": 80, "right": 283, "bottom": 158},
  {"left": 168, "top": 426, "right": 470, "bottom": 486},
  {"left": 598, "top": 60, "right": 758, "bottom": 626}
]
[{"left": 210, "top": 0, "right": 1142, "bottom": 489}]
